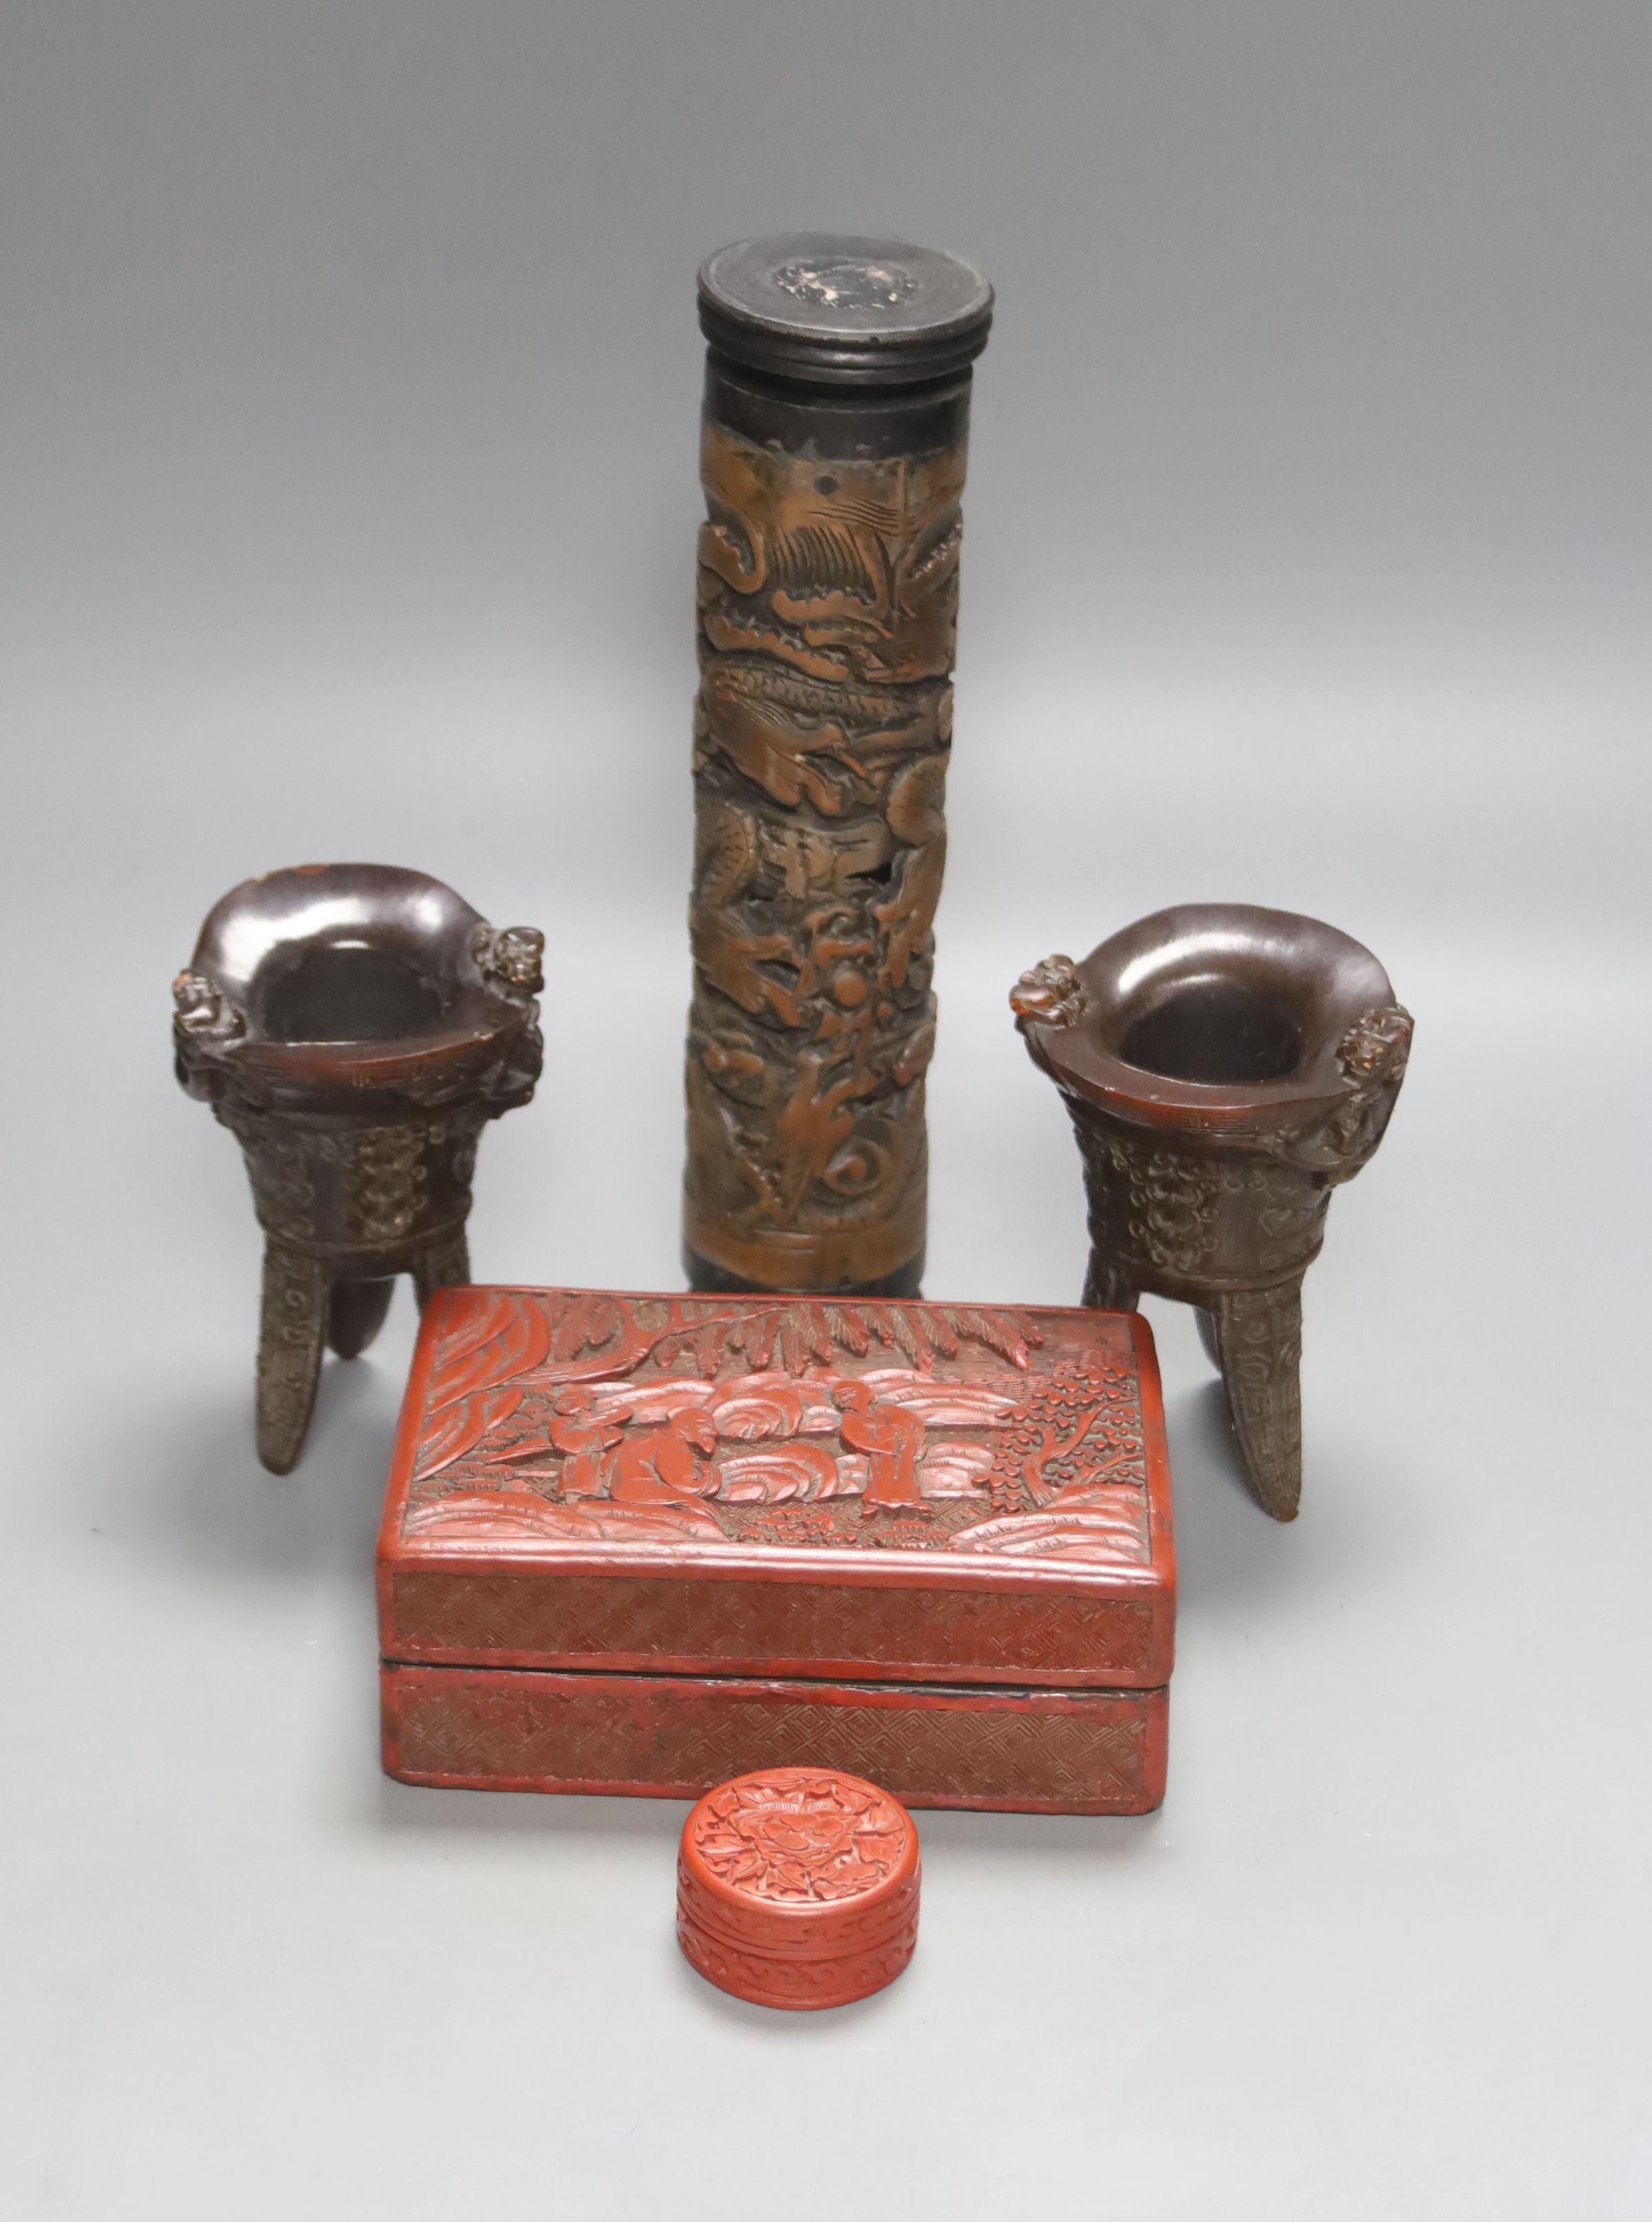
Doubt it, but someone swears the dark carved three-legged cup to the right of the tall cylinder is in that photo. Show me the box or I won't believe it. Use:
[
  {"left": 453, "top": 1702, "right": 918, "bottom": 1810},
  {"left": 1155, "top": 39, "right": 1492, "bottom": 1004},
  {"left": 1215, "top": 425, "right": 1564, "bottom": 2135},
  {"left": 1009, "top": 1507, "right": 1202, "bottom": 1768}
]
[{"left": 1011, "top": 902, "right": 1412, "bottom": 1520}]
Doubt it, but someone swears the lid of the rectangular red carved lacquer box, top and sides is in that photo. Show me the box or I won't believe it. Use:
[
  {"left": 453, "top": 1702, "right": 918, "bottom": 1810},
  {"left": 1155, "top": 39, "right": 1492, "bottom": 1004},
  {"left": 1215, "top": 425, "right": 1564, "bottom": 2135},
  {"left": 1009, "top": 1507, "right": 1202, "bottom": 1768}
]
[{"left": 380, "top": 1289, "right": 1173, "bottom": 1685}]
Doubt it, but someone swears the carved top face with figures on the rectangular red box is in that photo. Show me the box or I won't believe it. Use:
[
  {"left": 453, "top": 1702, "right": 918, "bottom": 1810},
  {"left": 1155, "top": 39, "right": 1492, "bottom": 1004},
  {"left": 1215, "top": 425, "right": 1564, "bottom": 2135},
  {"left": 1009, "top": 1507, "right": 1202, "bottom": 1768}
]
[{"left": 404, "top": 1291, "right": 1148, "bottom": 1564}]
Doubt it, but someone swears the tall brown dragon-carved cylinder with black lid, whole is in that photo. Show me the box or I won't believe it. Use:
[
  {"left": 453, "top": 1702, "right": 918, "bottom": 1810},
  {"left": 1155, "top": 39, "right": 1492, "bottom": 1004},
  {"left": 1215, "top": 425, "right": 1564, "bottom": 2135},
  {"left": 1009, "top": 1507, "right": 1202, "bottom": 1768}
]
[{"left": 684, "top": 234, "right": 993, "bottom": 1295}]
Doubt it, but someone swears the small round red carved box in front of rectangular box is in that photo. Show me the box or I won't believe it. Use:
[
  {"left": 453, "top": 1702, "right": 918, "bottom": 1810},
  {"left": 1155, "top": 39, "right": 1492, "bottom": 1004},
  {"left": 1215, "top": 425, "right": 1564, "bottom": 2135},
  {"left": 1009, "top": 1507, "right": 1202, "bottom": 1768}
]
[{"left": 677, "top": 1767, "right": 919, "bottom": 2011}]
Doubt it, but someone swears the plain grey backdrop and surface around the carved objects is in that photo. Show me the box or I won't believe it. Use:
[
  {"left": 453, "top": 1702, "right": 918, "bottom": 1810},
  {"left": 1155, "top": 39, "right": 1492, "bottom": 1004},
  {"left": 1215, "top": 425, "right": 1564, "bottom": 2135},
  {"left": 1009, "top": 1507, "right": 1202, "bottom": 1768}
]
[{"left": 0, "top": 0, "right": 1652, "bottom": 2222}]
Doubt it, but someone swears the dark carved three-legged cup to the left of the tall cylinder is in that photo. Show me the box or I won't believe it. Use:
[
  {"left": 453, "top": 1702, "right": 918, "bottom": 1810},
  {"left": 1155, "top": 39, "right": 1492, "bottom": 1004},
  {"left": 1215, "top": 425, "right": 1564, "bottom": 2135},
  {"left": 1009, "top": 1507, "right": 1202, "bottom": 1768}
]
[{"left": 173, "top": 865, "right": 544, "bottom": 1473}]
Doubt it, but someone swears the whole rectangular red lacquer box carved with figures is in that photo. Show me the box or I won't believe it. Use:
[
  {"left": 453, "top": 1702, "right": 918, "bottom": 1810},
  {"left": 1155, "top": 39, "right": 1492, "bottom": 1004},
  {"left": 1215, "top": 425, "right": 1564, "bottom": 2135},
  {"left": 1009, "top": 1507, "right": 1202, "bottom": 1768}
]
[{"left": 378, "top": 1289, "right": 1175, "bottom": 1813}]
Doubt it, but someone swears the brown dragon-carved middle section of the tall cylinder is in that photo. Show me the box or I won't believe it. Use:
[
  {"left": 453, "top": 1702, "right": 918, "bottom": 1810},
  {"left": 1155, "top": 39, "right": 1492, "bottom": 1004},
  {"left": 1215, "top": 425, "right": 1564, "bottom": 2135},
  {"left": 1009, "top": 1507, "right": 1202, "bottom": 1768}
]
[{"left": 688, "top": 424, "right": 964, "bottom": 1284}]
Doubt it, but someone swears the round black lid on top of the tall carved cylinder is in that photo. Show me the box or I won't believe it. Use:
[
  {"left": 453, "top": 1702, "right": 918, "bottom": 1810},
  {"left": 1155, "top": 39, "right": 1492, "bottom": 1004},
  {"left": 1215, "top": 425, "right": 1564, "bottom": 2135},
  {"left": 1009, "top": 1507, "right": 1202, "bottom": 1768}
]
[{"left": 699, "top": 231, "right": 993, "bottom": 387}]
